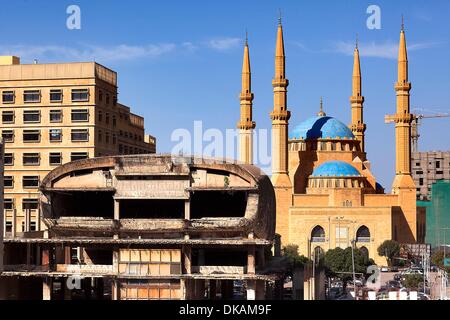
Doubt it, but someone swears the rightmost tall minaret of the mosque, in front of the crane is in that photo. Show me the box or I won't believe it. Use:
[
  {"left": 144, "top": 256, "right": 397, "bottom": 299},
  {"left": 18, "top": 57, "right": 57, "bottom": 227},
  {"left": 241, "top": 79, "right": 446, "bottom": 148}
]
[{"left": 393, "top": 22, "right": 414, "bottom": 193}]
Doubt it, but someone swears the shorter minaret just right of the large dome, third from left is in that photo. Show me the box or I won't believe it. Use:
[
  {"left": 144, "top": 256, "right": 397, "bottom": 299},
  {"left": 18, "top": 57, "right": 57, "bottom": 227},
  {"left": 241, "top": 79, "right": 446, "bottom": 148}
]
[{"left": 350, "top": 40, "right": 366, "bottom": 152}]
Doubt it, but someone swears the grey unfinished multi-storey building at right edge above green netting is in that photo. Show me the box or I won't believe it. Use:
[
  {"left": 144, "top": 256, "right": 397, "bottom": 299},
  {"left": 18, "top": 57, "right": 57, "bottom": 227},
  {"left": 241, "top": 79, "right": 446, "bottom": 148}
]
[{"left": 411, "top": 151, "right": 450, "bottom": 200}]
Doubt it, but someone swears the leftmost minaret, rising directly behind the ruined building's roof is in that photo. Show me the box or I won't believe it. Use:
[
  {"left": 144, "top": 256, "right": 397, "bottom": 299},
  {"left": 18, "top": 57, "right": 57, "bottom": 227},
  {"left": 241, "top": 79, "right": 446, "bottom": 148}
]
[{"left": 237, "top": 36, "right": 256, "bottom": 164}]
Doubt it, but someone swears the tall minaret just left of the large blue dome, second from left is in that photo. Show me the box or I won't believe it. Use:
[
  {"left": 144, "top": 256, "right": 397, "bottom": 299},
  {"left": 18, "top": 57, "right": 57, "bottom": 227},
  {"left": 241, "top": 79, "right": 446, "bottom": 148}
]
[{"left": 270, "top": 18, "right": 291, "bottom": 187}]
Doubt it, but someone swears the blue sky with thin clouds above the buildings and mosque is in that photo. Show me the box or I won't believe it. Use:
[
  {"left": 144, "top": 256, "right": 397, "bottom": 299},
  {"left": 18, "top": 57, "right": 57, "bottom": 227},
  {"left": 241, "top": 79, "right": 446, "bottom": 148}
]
[{"left": 0, "top": 0, "right": 450, "bottom": 189}]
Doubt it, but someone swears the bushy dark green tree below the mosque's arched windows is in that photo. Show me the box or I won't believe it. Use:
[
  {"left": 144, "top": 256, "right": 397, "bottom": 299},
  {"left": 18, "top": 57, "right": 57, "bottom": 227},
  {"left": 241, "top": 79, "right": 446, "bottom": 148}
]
[{"left": 324, "top": 247, "right": 374, "bottom": 283}]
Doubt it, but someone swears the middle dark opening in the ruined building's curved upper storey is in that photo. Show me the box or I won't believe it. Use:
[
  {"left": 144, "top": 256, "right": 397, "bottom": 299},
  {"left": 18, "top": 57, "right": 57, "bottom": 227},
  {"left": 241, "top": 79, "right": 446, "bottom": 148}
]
[{"left": 120, "top": 199, "right": 184, "bottom": 219}]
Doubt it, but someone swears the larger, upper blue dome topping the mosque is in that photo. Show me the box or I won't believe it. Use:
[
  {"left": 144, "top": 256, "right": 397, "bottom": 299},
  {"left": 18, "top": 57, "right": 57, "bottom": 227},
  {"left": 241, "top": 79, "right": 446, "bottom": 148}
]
[{"left": 289, "top": 116, "right": 355, "bottom": 139}]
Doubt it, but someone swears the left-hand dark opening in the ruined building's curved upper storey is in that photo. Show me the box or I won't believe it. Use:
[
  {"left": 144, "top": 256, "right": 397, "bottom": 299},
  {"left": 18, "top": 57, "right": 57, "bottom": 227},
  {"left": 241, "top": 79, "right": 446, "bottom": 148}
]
[{"left": 52, "top": 191, "right": 114, "bottom": 219}]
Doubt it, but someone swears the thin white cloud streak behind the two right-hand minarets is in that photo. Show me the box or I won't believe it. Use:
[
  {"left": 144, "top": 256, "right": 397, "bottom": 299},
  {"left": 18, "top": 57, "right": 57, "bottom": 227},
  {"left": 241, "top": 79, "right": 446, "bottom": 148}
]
[{"left": 334, "top": 41, "right": 440, "bottom": 59}]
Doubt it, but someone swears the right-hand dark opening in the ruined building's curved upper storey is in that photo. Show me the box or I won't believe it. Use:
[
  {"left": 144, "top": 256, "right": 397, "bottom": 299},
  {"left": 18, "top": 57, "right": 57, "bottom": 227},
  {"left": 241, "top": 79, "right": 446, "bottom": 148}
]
[{"left": 191, "top": 191, "right": 247, "bottom": 219}]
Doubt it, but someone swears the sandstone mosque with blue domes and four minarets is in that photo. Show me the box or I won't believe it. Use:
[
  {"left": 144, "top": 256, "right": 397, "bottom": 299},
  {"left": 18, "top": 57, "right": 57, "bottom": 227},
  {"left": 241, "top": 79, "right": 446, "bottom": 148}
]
[{"left": 237, "top": 21, "right": 425, "bottom": 265}]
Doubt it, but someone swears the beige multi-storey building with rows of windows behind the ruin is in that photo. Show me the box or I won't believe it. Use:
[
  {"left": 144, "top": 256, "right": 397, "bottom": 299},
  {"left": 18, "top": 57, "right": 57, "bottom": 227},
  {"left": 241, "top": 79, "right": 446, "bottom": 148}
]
[{"left": 0, "top": 56, "right": 156, "bottom": 237}]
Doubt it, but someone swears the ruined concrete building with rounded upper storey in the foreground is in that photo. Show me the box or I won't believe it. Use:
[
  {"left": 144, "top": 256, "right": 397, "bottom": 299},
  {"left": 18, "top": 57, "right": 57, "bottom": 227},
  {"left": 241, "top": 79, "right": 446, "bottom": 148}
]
[{"left": 0, "top": 155, "right": 276, "bottom": 300}]
